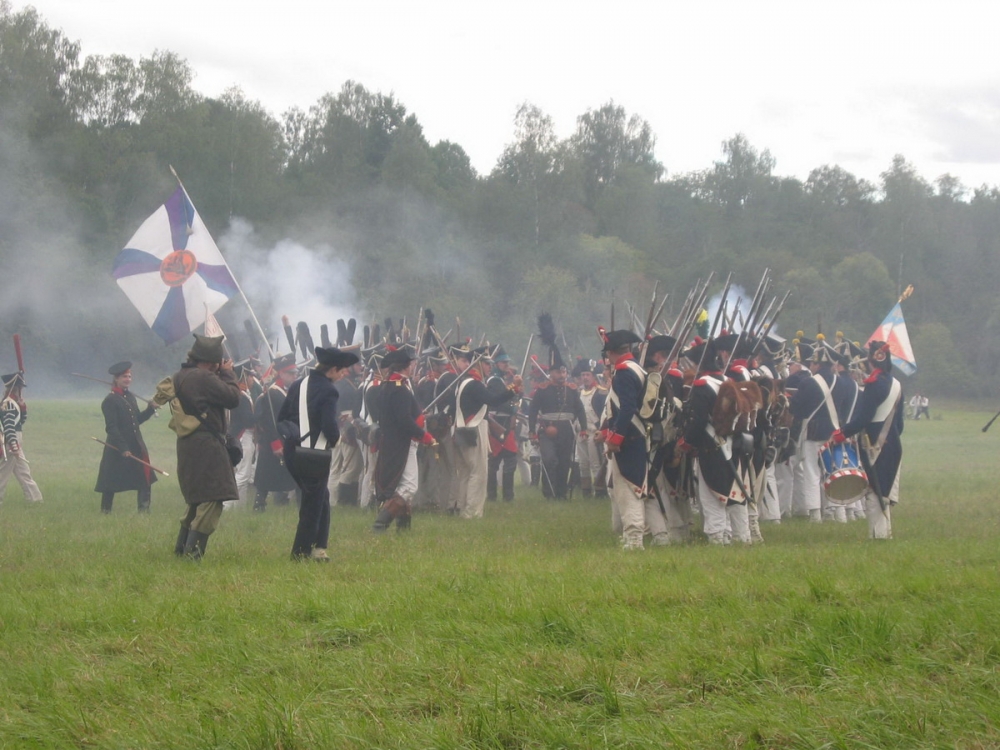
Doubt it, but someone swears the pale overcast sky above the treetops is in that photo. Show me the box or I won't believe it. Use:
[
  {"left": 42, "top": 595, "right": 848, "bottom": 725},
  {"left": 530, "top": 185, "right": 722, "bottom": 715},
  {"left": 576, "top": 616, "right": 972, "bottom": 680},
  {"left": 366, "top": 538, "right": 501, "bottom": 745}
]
[{"left": 13, "top": 0, "right": 1000, "bottom": 194}]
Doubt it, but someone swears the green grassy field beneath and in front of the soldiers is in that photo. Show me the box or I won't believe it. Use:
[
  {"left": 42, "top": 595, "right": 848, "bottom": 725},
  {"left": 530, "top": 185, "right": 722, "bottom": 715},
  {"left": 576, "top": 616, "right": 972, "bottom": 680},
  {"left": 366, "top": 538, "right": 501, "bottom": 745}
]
[{"left": 0, "top": 401, "right": 1000, "bottom": 750}]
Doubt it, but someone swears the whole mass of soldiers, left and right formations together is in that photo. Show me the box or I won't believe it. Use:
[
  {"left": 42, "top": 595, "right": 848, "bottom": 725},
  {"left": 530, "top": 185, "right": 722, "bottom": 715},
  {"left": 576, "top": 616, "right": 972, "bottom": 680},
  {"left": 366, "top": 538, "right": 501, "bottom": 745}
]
[{"left": 197, "top": 296, "right": 902, "bottom": 549}]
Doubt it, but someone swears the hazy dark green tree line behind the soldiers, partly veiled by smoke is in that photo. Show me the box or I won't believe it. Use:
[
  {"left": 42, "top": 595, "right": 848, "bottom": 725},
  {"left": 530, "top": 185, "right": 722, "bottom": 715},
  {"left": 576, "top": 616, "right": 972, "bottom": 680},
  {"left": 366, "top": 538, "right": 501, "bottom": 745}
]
[{"left": 0, "top": 0, "right": 1000, "bottom": 395}]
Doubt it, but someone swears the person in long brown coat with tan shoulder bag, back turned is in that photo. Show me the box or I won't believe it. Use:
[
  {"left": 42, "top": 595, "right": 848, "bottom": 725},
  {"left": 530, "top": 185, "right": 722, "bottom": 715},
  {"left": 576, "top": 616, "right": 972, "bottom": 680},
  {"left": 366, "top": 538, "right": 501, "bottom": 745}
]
[{"left": 173, "top": 334, "right": 240, "bottom": 560}]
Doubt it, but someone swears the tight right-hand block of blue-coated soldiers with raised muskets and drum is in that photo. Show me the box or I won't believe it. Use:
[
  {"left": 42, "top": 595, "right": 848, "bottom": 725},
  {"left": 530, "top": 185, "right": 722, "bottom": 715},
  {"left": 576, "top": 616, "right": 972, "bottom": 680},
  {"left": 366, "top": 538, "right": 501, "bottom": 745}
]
[{"left": 603, "top": 330, "right": 903, "bottom": 549}]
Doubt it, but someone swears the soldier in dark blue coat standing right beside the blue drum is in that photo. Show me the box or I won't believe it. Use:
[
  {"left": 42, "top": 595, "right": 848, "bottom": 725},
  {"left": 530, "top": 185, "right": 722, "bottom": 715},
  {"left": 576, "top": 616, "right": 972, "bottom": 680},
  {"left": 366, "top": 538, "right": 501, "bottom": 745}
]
[{"left": 831, "top": 341, "right": 903, "bottom": 539}]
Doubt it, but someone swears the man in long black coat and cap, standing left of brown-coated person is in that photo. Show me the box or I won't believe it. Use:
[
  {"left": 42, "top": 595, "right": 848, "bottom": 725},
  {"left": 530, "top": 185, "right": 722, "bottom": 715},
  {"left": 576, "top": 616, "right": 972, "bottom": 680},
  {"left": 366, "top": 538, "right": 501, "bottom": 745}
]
[{"left": 94, "top": 362, "right": 156, "bottom": 513}]
